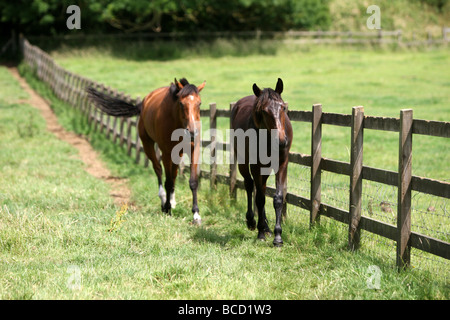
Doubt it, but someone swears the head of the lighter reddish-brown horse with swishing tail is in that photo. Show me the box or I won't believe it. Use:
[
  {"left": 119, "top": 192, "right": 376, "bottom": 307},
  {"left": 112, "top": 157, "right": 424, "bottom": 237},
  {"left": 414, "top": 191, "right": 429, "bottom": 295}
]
[{"left": 175, "top": 78, "right": 206, "bottom": 141}]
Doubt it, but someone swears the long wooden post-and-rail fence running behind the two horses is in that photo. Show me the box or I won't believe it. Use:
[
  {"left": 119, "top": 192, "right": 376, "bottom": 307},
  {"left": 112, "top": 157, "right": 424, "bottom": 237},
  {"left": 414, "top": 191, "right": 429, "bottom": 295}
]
[{"left": 21, "top": 39, "right": 450, "bottom": 269}]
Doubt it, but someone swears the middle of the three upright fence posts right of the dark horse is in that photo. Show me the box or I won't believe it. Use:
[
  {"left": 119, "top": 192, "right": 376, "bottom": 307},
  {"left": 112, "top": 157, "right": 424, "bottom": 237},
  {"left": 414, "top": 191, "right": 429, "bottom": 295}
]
[{"left": 348, "top": 107, "right": 364, "bottom": 251}]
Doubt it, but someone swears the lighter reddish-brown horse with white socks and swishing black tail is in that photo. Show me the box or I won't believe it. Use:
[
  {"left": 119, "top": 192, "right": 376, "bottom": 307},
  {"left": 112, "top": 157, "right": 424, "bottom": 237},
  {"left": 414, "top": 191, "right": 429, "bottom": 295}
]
[{"left": 87, "top": 78, "right": 205, "bottom": 224}]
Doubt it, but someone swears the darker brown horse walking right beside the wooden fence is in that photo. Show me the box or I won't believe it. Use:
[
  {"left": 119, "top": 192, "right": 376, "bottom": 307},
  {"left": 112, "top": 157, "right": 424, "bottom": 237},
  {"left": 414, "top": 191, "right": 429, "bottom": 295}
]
[{"left": 231, "top": 79, "right": 292, "bottom": 246}]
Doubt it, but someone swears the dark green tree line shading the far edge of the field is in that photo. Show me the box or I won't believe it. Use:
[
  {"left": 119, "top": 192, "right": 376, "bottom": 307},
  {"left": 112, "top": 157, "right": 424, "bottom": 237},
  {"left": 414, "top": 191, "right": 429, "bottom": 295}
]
[{"left": 0, "top": 0, "right": 331, "bottom": 36}]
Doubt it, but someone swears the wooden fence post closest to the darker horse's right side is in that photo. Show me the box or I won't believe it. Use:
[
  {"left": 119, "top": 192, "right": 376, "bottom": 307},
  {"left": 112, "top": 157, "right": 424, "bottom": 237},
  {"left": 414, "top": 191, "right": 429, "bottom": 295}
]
[{"left": 309, "top": 104, "right": 322, "bottom": 227}]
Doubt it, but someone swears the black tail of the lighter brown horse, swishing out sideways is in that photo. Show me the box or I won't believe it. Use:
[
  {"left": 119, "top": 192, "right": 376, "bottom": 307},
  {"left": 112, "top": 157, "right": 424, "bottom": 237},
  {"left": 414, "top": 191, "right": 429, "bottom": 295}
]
[{"left": 86, "top": 87, "right": 142, "bottom": 117}]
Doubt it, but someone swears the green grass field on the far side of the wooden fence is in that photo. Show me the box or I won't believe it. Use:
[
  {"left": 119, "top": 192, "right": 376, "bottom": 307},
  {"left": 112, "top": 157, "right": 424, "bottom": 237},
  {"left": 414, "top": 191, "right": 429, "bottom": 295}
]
[{"left": 53, "top": 41, "right": 450, "bottom": 180}]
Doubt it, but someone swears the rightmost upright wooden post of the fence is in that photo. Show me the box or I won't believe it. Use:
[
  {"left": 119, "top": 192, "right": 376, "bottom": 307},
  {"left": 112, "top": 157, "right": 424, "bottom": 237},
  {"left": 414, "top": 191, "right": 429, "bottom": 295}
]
[{"left": 397, "top": 109, "right": 413, "bottom": 270}]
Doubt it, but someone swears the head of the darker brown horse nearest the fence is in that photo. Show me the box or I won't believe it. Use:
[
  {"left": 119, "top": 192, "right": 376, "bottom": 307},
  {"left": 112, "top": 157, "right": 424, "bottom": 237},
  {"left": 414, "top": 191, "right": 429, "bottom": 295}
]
[{"left": 253, "top": 78, "right": 289, "bottom": 147}]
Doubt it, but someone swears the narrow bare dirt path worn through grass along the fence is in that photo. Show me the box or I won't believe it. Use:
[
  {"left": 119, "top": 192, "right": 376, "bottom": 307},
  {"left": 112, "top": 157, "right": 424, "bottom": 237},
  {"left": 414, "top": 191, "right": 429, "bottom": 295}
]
[{"left": 8, "top": 67, "right": 131, "bottom": 206}]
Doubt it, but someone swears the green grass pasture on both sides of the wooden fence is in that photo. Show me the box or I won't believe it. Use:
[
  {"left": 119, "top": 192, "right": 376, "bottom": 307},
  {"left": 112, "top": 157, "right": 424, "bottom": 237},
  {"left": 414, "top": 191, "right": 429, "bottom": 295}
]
[{"left": 0, "top": 40, "right": 450, "bottom": 299}]
